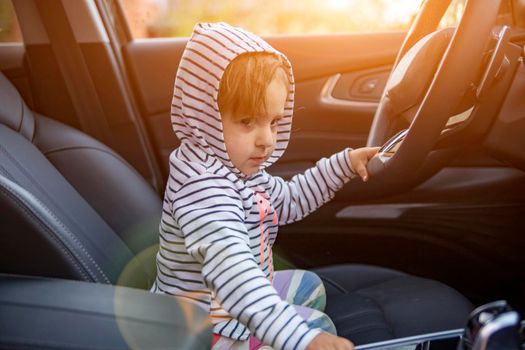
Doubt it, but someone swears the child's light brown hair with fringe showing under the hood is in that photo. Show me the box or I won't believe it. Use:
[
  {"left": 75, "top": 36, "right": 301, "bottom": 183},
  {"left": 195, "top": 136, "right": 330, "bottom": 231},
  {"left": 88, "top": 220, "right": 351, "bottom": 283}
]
[{"left": 217, "top": 52, "right": 290, "bottom": 118}]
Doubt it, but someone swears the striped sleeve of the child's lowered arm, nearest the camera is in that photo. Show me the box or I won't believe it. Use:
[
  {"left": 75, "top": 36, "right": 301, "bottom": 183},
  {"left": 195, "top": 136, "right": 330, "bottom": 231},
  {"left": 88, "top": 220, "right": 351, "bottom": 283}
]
[{"left": 173, "top": 177, "right": 320, "bottom": 349}]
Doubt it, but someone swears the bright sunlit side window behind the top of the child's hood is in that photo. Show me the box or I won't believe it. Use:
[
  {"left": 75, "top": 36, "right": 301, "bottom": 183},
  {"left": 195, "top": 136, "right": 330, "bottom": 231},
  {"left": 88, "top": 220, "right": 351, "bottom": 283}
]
[{"left": 120, "top": 0, "right": 420, "bottom": 38}]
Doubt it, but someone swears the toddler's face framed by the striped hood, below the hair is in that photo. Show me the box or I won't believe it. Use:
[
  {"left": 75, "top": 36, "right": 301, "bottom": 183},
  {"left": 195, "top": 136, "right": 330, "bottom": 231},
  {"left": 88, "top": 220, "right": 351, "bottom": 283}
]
[{"left": 222, "top": 77, "right": 288, "bottom": 175}]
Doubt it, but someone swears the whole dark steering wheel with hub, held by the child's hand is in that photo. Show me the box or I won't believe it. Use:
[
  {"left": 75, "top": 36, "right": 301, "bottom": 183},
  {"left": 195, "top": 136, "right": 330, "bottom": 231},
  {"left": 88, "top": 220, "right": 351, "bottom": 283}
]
[{"left": 367, "top": 0, "right": 500, "bottom": 184}]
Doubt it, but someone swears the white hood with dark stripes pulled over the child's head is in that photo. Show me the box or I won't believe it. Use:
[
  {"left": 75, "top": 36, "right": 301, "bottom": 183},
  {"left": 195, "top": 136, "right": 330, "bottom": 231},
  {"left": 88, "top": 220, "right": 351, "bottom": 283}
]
[{"left": 171, "top": 23, "right": 295, "bottom": 177}]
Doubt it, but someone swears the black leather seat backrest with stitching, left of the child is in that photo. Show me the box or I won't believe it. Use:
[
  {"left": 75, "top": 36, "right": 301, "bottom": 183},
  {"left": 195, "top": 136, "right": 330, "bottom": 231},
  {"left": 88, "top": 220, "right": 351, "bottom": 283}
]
[{"left": 0, "top": 75, "right": 162, "bottom": 288}]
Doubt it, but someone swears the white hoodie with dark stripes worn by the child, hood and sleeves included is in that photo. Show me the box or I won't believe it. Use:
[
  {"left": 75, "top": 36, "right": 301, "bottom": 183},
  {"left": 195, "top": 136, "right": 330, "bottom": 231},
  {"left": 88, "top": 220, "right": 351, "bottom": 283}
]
[{"left": 152, "top": 23, "right": 354, "bottom": 349}]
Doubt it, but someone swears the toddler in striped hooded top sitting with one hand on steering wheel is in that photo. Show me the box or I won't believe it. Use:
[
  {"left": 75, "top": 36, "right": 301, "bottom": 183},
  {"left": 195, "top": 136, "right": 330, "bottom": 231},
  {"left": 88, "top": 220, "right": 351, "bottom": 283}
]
[{"left": 152, "top": 23, "right": 377, "bottom": 350}]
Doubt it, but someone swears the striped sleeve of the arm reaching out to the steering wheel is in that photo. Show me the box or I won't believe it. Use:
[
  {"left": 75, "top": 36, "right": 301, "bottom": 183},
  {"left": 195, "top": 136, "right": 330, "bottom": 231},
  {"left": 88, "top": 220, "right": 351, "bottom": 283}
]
[{"left": 269, "top": 148, "right": 357, "bottom": 225}]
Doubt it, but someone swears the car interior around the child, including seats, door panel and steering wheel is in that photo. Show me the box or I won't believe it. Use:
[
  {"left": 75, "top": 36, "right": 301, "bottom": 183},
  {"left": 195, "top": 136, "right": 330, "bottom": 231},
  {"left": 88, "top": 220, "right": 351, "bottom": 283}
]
[{"left": 0, "top": 0, "right": 525, "bottom": 349}]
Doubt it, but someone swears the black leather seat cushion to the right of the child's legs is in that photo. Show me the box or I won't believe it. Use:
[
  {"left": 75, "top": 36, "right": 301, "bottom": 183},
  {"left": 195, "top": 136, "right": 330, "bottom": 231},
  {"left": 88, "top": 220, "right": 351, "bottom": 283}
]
[{"left": 315, "top": 264, "right": 472, "bottom": 344}]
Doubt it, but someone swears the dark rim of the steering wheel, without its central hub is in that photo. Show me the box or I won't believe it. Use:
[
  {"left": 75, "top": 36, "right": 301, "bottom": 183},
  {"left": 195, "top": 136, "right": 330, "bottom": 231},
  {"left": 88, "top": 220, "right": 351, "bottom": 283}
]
[{"left": 367, "top": 0, "right": 500, "bottom": 182}]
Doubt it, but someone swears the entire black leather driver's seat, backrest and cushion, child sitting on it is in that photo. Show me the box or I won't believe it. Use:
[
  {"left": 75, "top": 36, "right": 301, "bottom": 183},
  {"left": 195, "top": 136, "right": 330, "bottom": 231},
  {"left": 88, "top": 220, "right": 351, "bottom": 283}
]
[{"left": 0, "top": 74, "right": 472, "bottom": 344}]
